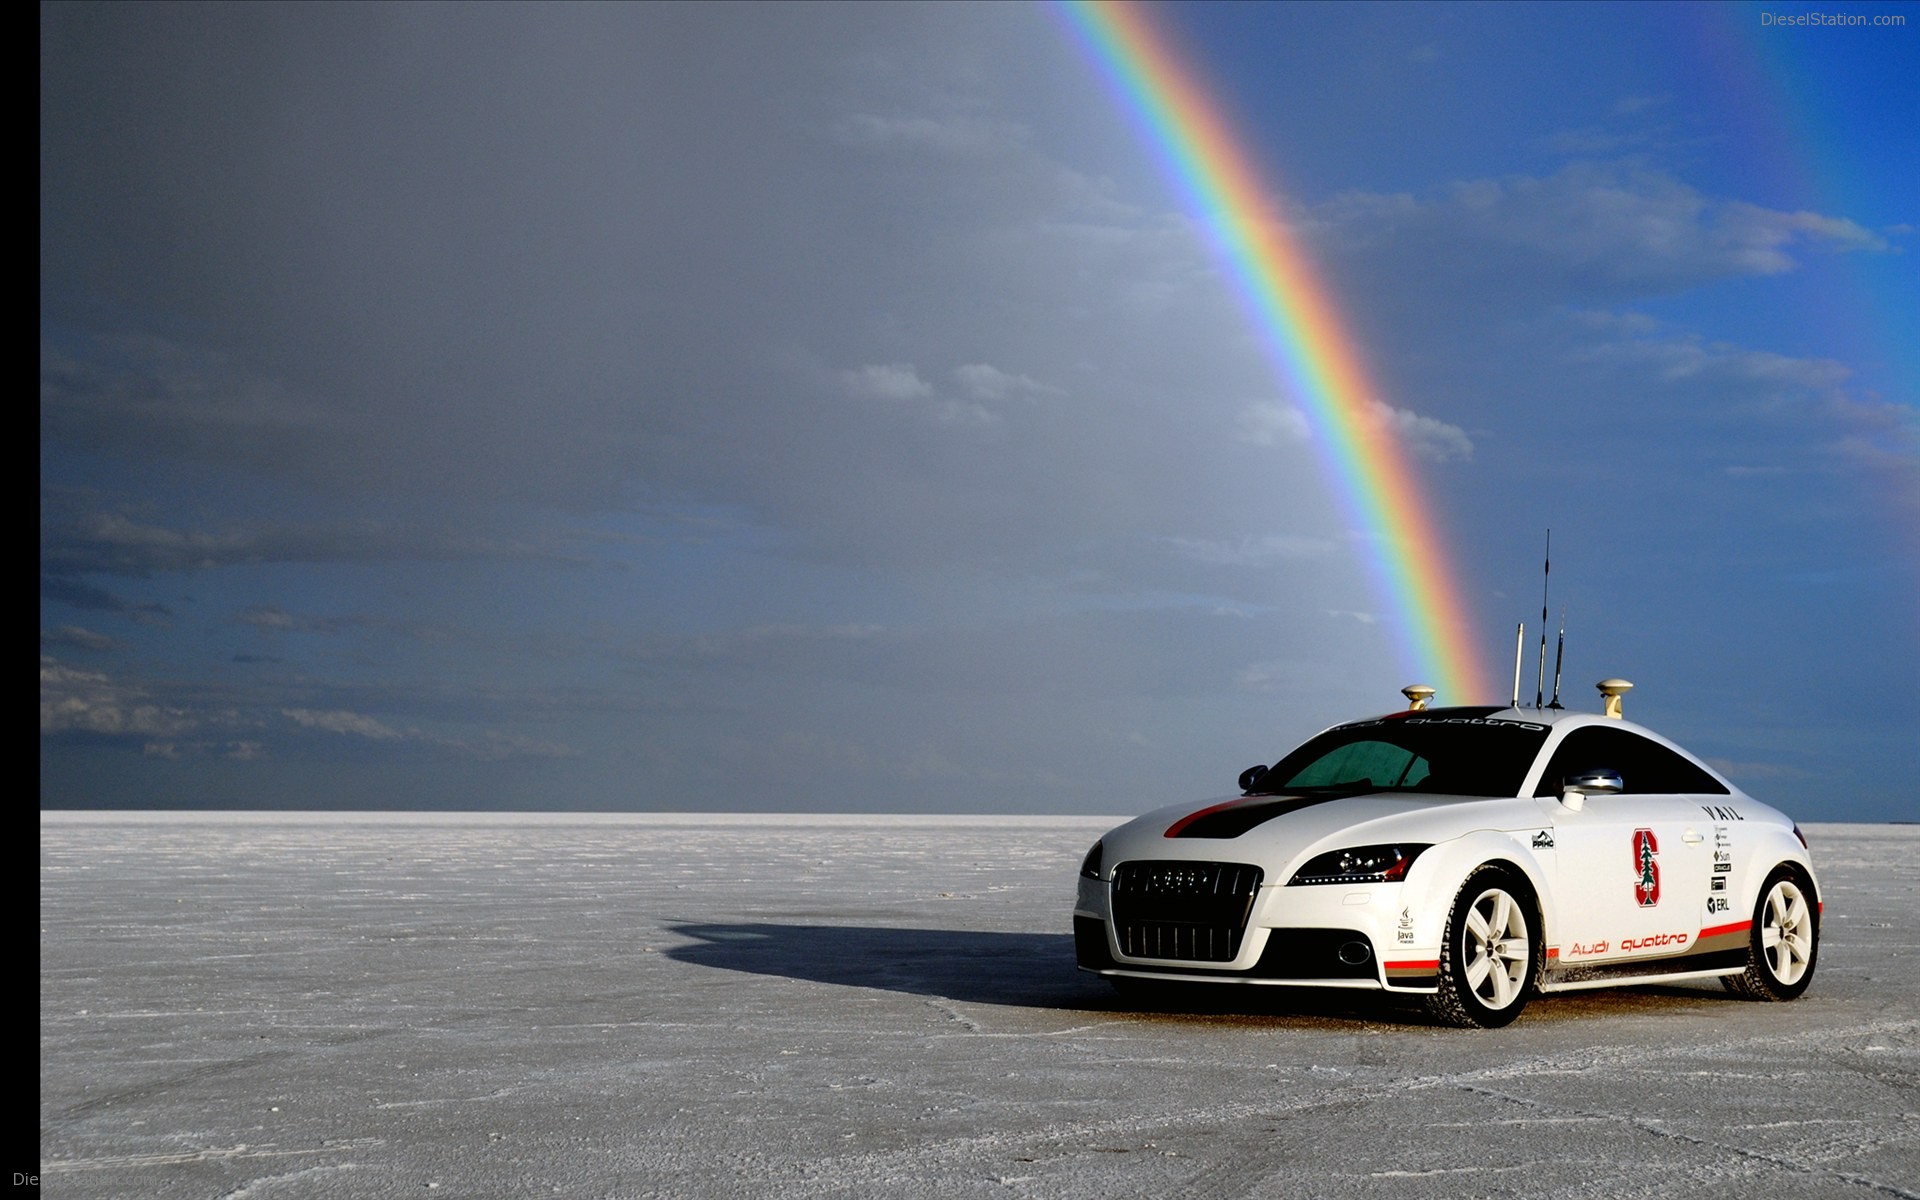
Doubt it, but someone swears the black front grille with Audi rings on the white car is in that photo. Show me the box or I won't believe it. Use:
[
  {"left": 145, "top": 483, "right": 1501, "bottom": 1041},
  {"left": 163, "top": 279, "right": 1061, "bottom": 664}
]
[{"left": 1112, "top": 860, "right": 1261, "bottom": 962}]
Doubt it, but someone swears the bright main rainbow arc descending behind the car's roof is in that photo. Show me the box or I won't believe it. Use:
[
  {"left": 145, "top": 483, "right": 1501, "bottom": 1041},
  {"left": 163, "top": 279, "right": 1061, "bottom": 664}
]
[{"left": 1056, "top": 0, "right": 1503, "bottom": 705}]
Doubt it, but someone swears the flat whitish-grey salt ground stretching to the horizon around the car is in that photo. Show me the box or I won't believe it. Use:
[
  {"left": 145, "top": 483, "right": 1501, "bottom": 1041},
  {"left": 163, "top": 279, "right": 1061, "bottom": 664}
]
[{"left": 40, "top": 812, "right": 1920, "bottom": 1200}]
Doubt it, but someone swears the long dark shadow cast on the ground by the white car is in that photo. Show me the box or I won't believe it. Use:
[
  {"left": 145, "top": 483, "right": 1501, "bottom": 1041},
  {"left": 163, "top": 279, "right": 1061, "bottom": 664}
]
[{"left": 666, "top": 922, "right": 1427, "bottom": 1023}]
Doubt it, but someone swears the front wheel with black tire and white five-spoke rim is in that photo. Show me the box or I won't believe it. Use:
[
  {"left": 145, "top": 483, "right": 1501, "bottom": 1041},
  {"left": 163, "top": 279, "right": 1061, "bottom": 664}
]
[{"left": 1427, "top": 866, "right": 1540, "bottom": 1029}]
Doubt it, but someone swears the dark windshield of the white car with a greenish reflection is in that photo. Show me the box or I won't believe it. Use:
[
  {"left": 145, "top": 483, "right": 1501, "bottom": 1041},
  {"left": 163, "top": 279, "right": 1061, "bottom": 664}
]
[{"left": 1248, "top": 714, "right": 1548, "bottom": 797}]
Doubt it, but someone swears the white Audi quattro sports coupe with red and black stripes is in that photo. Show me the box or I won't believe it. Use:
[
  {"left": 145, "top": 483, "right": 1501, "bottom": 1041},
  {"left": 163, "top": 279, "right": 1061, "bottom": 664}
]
[{"left": 1073, "top": 680, "right": 1820, "bottom": 1027}]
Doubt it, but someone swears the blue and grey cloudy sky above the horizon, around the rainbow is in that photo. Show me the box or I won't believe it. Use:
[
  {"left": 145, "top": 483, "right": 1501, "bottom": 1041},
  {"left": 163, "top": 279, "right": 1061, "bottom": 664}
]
[{"left": 38, "top": 4, "right": 1920, "bottom": 820}]
